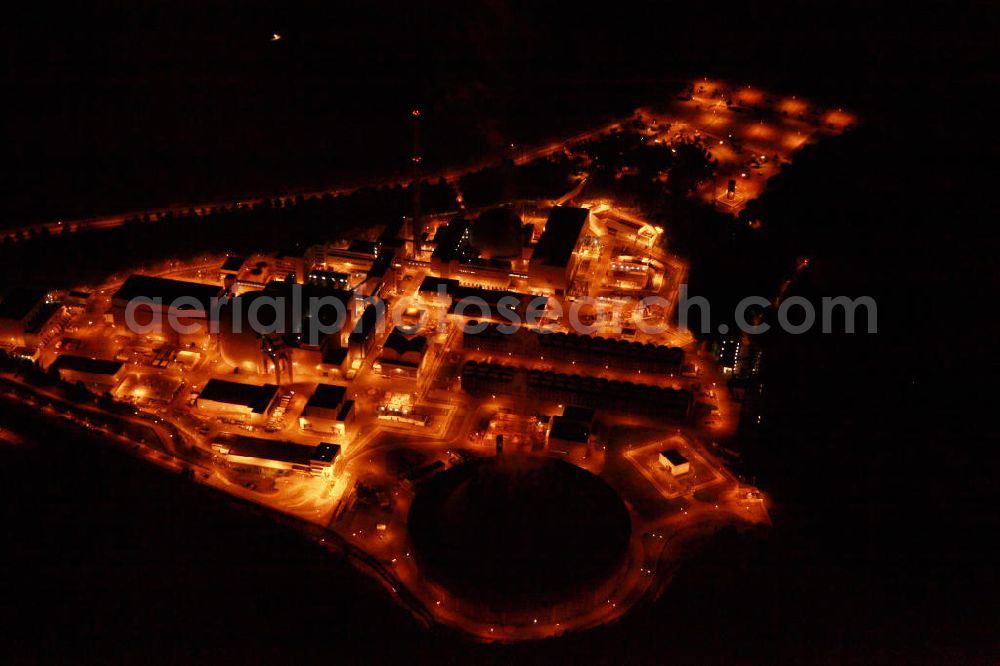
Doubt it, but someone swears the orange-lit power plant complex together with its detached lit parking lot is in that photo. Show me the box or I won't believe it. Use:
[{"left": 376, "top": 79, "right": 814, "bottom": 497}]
[{"left": 0, "top": 82, "right": 853, "bottom": 641}]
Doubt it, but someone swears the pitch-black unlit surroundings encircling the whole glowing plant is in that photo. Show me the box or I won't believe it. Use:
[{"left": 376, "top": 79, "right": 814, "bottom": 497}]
[{"left": 0, "top": 2, "right": 1000, "bottom": 663}]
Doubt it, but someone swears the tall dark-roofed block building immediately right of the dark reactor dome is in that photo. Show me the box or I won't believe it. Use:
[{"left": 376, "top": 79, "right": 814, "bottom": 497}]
[{"left": 528, "top": 206, "right": 590, "bottom": 296}]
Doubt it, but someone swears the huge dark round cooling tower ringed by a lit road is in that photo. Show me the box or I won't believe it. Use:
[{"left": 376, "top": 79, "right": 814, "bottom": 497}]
[{"left": 409, "top": 456, "right": 631, "bottom": 609}]
